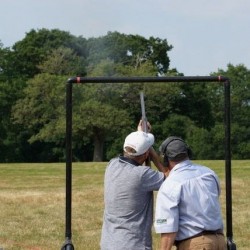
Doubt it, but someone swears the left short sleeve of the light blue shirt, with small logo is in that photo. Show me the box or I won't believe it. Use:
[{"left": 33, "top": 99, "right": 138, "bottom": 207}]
[{"left": 154, "top": 179, "right": 181, "bottom": 233}]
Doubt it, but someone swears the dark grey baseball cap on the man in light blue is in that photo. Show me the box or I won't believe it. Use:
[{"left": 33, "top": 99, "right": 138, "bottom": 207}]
[{"left": 159, "top": 136, "right": 188, "bottom": 159}]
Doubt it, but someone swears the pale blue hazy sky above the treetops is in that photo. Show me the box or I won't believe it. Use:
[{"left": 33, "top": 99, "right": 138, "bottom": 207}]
[{"left": 0, "top": 0, "right": 250, "bottom": 76}]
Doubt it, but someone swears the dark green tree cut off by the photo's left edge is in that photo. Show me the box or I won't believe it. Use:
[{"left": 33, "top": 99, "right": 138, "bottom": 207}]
[{"left": 0, "top": 45, "right": 30, "bottom": 162}]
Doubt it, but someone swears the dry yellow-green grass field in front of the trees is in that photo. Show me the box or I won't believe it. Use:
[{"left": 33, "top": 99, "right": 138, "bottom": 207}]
[{"left": 0, "top": 160, "right": 250, "bottom": 250}]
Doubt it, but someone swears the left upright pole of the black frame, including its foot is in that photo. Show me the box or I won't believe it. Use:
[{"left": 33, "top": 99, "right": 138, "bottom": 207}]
[{"left": 61, "top": 82, "right": 74, "bottom": 250}]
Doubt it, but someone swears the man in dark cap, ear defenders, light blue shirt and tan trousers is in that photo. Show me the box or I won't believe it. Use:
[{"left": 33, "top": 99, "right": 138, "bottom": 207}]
[{"left": 154, "top": 136, "right": 226, "bottom": 250}]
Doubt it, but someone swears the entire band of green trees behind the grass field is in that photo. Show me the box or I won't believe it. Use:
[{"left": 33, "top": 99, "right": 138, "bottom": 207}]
[{"left": 0, "top": 29, "right": 250, "bottom": 162}]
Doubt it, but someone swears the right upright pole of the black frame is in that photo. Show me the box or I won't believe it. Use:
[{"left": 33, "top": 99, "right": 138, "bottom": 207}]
[{"left": 224, "top": 80, "right": 236, "bottom": 250}]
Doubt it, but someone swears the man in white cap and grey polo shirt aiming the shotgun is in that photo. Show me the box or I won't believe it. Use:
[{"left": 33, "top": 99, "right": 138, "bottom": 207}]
[{"left": 101, "top": 122, "right": 166, "bottom": 250}]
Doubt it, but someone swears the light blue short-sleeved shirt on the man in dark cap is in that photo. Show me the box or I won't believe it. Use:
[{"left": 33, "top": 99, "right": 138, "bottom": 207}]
[{"left": 154, "top": 160, "right": 223, "bottom": 240}]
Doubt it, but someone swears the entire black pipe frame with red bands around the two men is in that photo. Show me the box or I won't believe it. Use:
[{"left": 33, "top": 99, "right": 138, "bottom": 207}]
[{"left": 62, "top": 76, "right": 236, "bottom": 250}]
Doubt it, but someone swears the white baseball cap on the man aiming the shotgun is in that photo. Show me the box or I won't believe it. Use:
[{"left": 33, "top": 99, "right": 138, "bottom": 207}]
[{"left": 123, "top": 131, "right": 155, "bottom": 156}]
